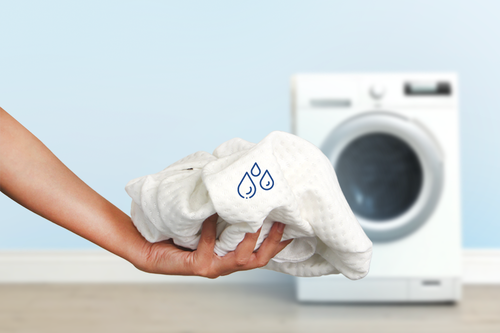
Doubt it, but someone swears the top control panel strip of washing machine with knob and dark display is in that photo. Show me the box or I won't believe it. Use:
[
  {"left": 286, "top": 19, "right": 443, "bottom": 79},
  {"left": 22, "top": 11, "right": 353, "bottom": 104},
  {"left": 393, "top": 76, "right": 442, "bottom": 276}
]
[{"left": 293, "top": 73, "right": 458, "bottom": 114}]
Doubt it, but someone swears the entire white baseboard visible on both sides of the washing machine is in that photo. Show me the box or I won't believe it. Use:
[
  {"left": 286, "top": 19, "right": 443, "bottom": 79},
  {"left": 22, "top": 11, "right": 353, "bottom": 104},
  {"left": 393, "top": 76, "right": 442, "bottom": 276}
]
[{"left": 0, "top": 249, "right": 500, "bottom": 284}]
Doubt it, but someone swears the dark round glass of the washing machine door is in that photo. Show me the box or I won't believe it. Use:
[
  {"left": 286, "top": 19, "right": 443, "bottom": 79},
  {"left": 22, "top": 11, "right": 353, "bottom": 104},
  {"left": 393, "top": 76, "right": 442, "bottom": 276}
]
[{"left": 335, "top": 133, "right": 423, "bottom": 222}]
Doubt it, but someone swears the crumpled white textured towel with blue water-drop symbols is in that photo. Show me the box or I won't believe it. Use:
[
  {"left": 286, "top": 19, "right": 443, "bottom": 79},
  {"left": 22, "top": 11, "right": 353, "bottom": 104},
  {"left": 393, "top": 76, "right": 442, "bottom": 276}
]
[{"left": 126, "top": 132, "right": 372, "bottom": 279}]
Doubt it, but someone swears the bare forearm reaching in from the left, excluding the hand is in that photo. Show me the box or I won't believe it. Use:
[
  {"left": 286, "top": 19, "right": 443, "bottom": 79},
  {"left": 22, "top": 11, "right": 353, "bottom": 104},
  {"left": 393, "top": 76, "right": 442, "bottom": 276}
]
[{"left": 0, "top": 108, "right": 149, "bottom": 262}]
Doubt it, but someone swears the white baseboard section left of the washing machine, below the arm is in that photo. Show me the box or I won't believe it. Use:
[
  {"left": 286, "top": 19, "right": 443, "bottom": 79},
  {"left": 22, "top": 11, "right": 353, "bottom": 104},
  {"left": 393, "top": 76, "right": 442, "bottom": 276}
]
[{"left": 0, "top": 250, "right": 293, "bottom": 283}]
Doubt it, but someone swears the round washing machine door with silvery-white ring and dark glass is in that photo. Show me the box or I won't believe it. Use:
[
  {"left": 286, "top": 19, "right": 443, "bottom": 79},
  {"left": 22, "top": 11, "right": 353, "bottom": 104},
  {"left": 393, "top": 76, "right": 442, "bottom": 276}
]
[{"left": 321, "top": 112, "right": 443, "bottom": 242}]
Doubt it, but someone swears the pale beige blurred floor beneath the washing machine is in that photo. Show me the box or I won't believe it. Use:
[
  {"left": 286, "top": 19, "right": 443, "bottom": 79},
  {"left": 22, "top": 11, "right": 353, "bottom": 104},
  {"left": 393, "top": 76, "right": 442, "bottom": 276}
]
[{"left": 0, "top": 283, "right": 500, "bottom": 333}]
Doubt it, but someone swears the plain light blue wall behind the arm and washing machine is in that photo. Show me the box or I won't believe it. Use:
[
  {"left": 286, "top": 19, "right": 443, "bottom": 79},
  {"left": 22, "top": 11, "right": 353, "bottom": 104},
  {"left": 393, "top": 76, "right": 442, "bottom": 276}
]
[{"left": 0, "top": 0, "right": 500, "bottom": 249}]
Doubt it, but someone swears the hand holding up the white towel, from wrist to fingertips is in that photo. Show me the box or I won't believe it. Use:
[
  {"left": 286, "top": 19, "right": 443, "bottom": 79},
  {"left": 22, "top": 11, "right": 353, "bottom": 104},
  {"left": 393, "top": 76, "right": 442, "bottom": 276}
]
[{"left": 134, "top": 214, "right": 292, "bottom": 279}]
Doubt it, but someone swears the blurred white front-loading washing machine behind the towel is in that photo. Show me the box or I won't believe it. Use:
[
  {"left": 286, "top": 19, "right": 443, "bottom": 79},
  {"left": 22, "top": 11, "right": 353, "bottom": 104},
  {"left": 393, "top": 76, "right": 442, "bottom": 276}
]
[{"left": 292, "top": 73, "right": 461, "bottom": 302}]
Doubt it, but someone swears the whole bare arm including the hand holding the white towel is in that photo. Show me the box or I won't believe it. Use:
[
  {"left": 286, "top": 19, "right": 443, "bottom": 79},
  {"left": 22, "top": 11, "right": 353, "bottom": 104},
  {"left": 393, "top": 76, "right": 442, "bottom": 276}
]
[{"left": 0, "top": 108, "right": 291, "bottom": 278}]
